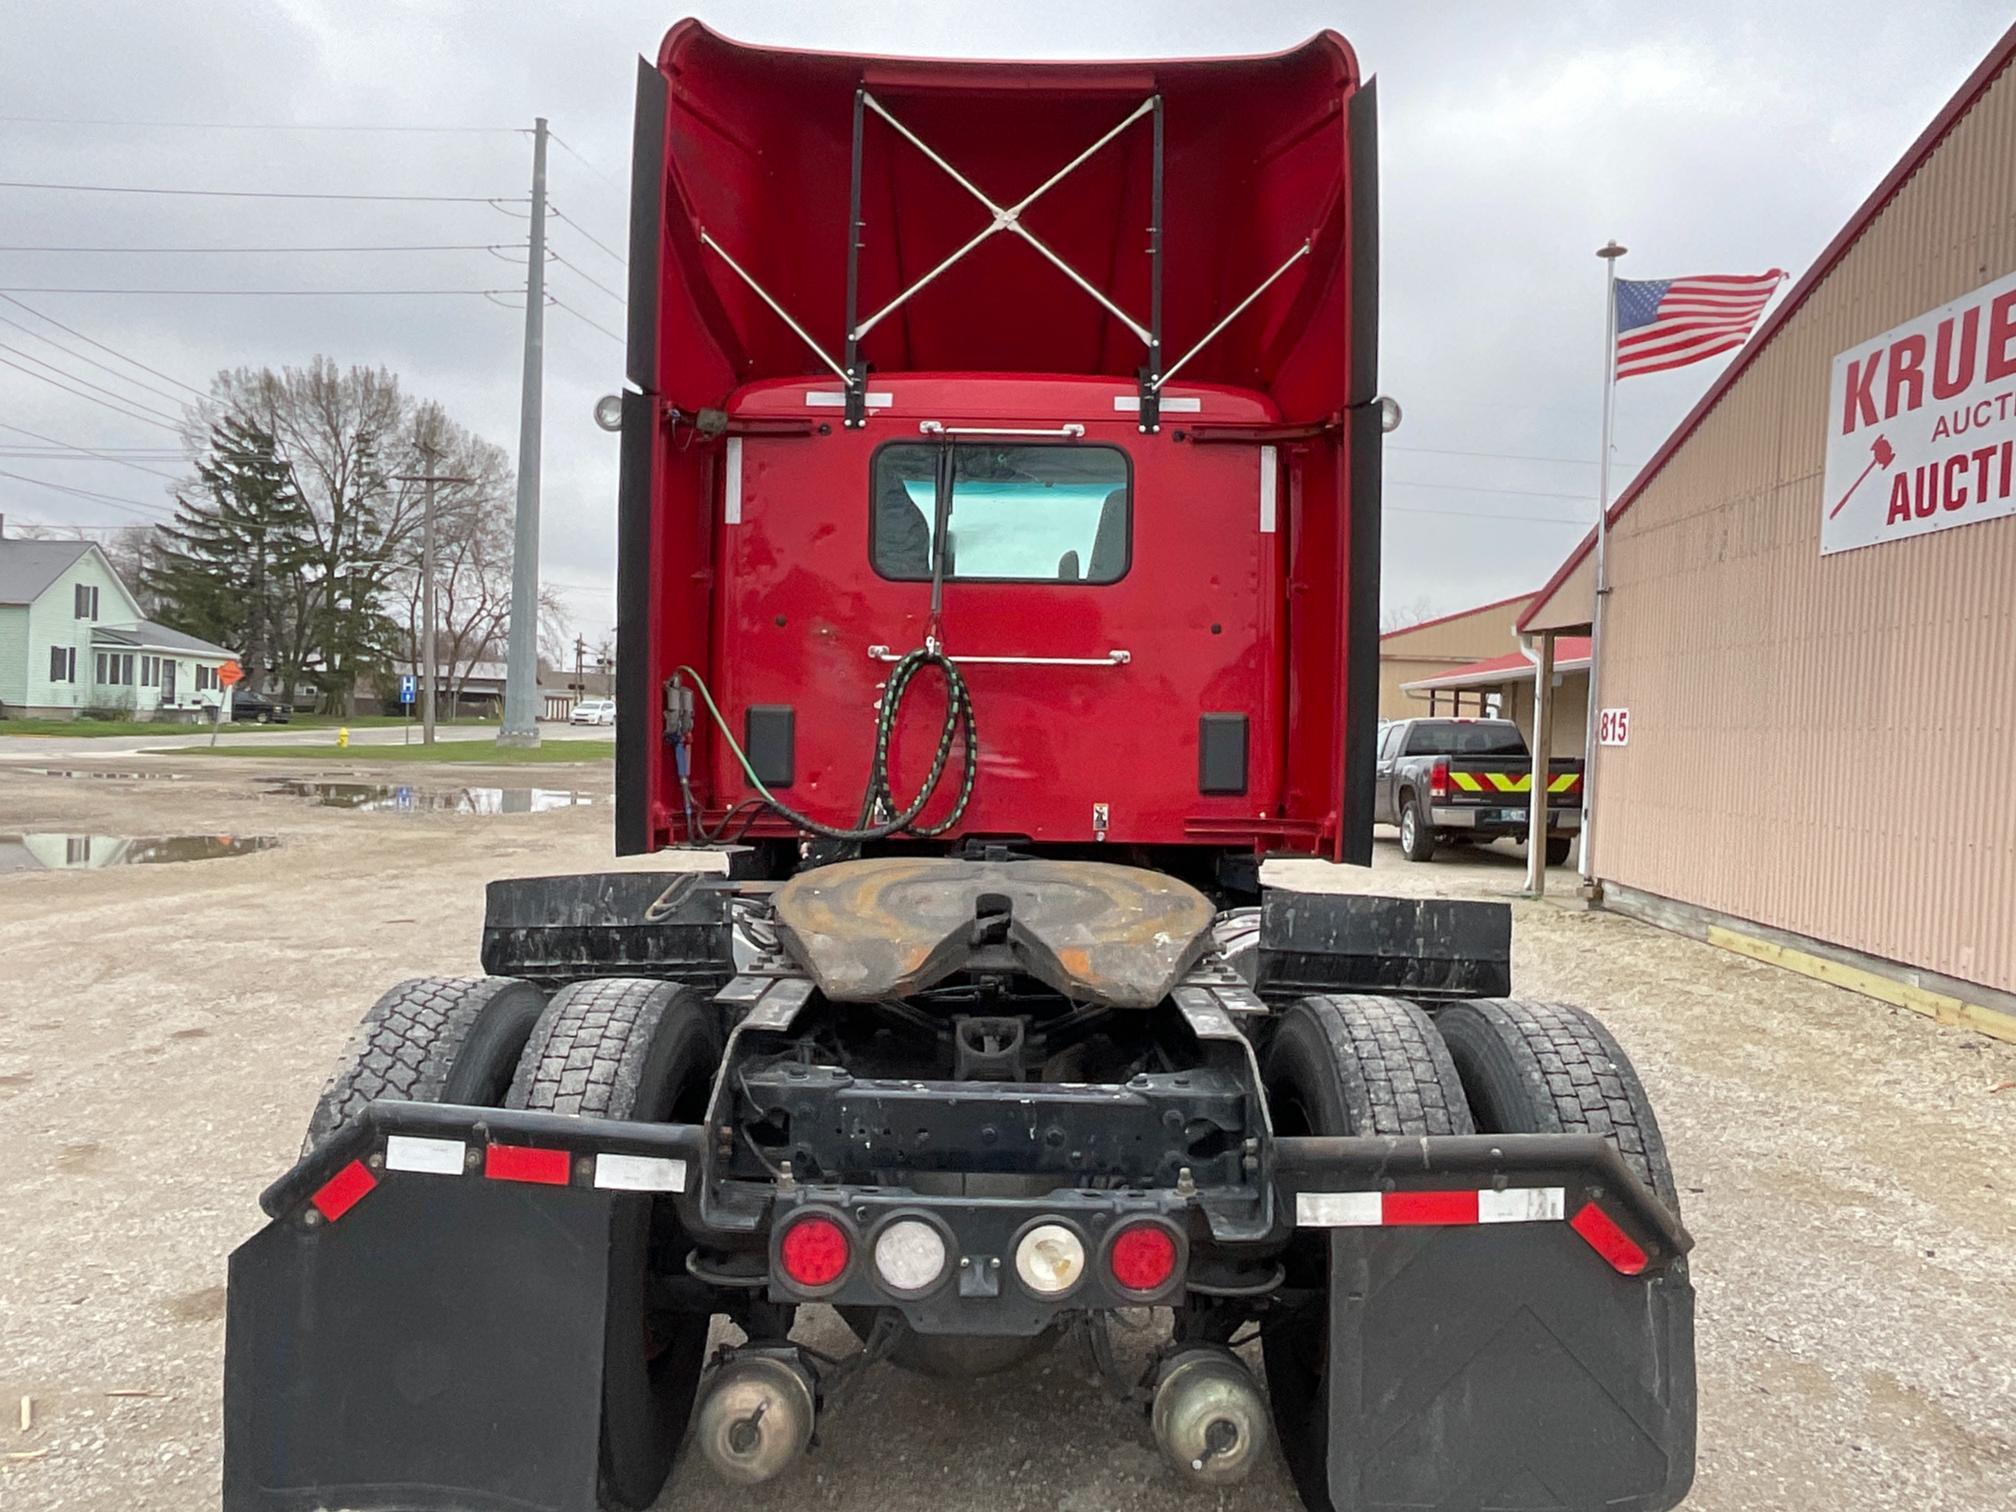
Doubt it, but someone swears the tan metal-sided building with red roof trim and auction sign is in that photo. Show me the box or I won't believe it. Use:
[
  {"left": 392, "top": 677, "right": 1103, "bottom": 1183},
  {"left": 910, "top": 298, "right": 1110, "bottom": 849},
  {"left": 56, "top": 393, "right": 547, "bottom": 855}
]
[{"left": 1520, "top": 28, "right": 2016, "bottom": 1038}]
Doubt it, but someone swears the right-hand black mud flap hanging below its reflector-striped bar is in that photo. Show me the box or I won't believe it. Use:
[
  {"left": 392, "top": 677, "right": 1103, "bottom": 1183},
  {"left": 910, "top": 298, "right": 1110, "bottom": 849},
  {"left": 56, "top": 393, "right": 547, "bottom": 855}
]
[{"left": 1294, "top": 1135, "right": 1695, "bottom": 1512}]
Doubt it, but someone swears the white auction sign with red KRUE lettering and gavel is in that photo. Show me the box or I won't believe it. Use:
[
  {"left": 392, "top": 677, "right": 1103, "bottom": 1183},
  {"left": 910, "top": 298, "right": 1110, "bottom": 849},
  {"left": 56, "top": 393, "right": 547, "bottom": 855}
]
[{"left": 1820, "top": 274, "right": 2016, "bottom": 556}]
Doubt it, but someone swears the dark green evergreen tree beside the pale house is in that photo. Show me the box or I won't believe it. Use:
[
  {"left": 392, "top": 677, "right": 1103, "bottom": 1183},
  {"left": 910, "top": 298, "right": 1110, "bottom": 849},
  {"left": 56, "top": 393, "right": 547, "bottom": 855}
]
[{"left": 141, "top": 415, "right": 317, "bottom": 691}]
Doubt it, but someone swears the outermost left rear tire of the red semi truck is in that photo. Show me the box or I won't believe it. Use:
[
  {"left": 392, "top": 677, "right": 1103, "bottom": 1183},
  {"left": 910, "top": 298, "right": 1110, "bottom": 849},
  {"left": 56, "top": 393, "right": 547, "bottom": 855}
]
[{"left": 302, "top": 976, "right": 546, "bottom": 1153}]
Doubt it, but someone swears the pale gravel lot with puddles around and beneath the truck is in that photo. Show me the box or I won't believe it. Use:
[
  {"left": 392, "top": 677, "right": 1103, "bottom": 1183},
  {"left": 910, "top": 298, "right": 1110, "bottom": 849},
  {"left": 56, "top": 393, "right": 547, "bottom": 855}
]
[{"left": 0, "top": 758, "right": 2016, "bottom": 1512}]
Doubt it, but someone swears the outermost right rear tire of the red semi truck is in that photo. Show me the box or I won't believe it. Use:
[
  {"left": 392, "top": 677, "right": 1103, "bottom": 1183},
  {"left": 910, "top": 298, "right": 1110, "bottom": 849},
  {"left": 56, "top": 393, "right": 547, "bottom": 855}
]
[{"left": 1435, "top": 998, "right": 1679, "bottom": 1216}]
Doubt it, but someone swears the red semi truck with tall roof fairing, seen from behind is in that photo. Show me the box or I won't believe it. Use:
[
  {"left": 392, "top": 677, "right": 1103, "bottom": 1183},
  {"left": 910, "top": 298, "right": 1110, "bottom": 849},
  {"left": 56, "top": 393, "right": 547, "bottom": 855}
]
[{"left": 224, "top": 22, "right": 1695, "bottom": 1512}]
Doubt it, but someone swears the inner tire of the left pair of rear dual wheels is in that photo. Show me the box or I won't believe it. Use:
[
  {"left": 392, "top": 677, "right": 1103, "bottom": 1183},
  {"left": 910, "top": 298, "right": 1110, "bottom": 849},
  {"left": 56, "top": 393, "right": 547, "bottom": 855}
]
[{"left": 506, "top": 978, "right": 722, "bottom": 1512}]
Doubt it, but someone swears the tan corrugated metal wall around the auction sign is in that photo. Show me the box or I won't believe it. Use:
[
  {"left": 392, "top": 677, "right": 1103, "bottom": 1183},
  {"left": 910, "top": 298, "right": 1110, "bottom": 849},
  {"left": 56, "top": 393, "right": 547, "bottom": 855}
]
[{"left": 1580, "top": 50, "right": 2016, "bottom": 990}]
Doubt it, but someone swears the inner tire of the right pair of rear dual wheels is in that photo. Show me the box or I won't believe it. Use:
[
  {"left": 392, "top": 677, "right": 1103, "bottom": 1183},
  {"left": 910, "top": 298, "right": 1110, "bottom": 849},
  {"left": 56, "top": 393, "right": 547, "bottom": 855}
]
[{"left": 1262, "top": 998, "right": 1474, "bottom": 1508}]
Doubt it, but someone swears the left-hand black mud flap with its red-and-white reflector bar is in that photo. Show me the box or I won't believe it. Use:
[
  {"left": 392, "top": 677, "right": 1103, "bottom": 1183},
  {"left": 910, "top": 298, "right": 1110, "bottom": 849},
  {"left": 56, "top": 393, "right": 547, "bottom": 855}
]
[{"left": 224, "top": 1103, "right": 698, "bottom": 1512}]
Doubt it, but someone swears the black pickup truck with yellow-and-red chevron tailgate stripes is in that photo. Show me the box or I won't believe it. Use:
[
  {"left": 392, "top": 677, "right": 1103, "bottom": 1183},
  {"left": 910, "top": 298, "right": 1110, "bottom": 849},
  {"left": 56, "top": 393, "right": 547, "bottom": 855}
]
[{"left": 1373, "top": 720, "right": 1583, "bottom": 867}]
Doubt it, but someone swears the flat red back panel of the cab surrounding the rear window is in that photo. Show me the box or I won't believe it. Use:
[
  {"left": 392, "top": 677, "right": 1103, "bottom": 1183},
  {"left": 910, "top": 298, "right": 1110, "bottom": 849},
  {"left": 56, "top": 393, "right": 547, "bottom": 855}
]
[{"left": 706, "top": 379, "right": 1284, "bottom": 843}]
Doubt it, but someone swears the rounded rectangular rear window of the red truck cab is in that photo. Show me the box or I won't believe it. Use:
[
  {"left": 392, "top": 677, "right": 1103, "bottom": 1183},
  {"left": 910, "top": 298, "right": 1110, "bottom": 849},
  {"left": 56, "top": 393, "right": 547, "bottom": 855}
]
[{"left": 869, "top": 442, "right": 1133, "bottom": 585}]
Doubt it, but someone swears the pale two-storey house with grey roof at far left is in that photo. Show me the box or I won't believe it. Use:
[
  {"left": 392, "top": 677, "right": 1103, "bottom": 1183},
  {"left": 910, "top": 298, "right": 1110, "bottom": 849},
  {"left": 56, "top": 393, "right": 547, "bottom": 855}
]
[{"left": 0, "top": 536, "right": 236, "bottom": 722}]
